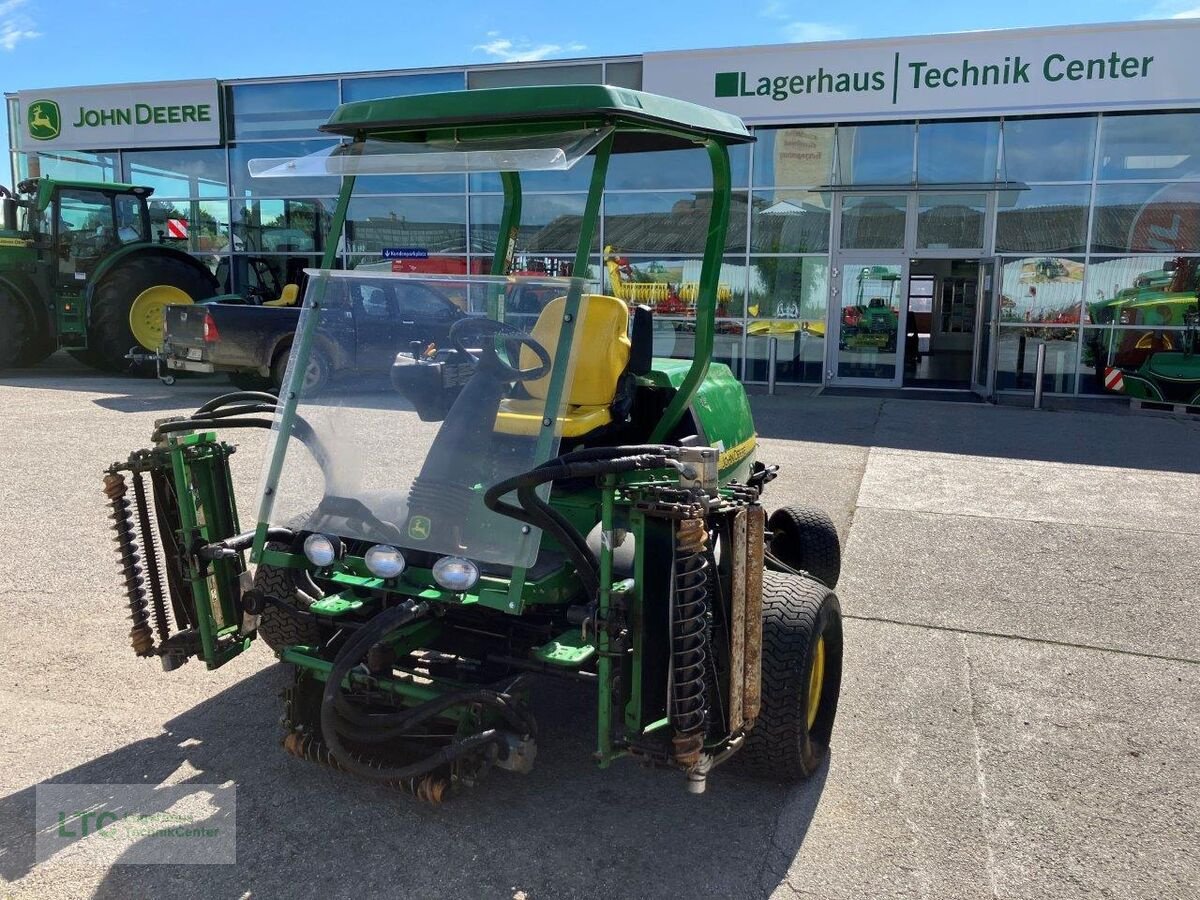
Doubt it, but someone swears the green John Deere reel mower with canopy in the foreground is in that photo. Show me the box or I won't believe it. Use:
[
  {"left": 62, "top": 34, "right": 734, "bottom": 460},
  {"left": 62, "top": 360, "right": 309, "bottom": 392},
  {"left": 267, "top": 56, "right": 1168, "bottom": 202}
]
[{"left": 104, "top": 85, "right": 842, "bottom": 802}]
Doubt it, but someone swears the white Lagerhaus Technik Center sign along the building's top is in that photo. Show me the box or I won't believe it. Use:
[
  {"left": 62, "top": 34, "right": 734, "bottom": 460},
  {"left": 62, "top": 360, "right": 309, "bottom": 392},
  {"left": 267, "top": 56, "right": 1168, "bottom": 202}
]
[{"left": 642, "top": 20, "right": 1200, "bottom": 122}]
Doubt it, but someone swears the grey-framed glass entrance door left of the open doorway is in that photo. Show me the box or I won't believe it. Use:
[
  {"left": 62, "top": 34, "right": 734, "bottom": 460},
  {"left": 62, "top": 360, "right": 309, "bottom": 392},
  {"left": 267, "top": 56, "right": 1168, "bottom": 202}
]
[{"left": 827, "top": 259, "right": 908, "bottom": 388}]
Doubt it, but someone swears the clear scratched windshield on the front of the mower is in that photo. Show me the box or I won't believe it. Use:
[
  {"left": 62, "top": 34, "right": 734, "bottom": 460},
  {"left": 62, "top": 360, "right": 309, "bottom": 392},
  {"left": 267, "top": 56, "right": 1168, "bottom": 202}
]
[{"left": 259, "top": 270, "right": 588, "bottom": 566}]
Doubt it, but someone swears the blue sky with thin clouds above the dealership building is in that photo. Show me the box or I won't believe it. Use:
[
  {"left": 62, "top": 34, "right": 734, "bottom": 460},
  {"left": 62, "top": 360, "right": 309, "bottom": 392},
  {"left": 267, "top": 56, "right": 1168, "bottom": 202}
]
[{"left": 0, "top": 0, "right": 1200, "bottom": 151}]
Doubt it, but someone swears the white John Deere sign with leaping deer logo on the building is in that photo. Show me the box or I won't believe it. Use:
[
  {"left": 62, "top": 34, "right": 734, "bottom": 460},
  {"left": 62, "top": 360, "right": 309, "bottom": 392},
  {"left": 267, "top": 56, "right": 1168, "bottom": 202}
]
[{"left": 18, "top": 80, "right": 221, "bottom": 150}]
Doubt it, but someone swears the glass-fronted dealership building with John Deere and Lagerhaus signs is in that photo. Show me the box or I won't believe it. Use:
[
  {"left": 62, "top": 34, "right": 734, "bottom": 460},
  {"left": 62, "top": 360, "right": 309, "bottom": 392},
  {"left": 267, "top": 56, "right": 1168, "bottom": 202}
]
[{"left": 6, "top": 20, "right": 1200, "bottom": 395}]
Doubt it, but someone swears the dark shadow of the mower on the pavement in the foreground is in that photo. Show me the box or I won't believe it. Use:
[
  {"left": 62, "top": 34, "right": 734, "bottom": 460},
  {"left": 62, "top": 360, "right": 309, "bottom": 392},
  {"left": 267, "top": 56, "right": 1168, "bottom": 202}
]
[{"left": 0, "top": 665, "right": 826, "bottom": 900}]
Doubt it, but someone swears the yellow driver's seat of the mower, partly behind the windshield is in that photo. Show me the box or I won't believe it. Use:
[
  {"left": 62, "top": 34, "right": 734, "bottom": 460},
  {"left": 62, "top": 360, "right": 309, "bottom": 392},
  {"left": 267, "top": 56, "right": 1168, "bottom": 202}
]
[{"left": 496, "top": 294, "right": 630, "bottom": 438}]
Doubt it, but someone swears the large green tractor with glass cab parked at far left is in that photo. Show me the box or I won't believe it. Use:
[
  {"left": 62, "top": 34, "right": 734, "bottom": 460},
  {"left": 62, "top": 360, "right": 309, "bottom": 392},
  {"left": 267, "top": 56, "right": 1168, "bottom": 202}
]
[{"left": 0, "top": 178, "right": 217, "bottom": 372}]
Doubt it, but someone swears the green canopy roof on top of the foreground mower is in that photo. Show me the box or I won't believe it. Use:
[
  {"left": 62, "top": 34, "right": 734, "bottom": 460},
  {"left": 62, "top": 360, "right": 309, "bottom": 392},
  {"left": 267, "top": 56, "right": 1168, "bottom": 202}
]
[{"left": 322, "top": 84, "right": 754, "bottom": 152}]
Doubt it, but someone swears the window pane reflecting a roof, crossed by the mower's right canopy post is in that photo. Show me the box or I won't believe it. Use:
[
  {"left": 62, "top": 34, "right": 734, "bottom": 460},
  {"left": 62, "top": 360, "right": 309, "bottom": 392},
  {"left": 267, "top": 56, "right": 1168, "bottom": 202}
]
[{"left": 604, "top": 191, "right": 746, "bottom": 253}]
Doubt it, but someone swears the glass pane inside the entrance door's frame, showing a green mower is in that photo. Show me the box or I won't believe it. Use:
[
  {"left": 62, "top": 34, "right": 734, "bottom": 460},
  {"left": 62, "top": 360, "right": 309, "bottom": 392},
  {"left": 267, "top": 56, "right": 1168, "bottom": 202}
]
[{"left": 838, "top": 263, "right": 902, "bottom": 382}]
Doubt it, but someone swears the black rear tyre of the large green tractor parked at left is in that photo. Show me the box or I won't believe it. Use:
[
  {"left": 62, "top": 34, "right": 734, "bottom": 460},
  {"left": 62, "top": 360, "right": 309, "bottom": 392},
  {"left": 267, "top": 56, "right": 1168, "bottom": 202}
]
[{"left": 78, "top": 256, "right": 215, "bottom": 372}]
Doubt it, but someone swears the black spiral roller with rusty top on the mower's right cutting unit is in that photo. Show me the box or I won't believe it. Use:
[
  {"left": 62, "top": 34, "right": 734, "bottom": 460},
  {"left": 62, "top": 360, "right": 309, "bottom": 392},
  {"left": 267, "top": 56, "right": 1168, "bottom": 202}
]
[{"left": 671, "top": 518, "right": 708, "bottom": 763}]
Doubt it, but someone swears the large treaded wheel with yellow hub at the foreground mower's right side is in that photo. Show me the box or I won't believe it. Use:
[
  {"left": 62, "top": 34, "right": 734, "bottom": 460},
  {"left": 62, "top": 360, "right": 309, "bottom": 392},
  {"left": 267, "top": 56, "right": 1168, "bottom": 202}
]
[{"left": 738, "top": 570, "right": 842, "bottom": 781}]
